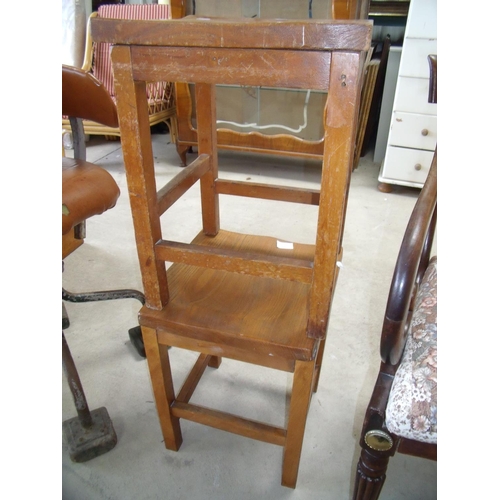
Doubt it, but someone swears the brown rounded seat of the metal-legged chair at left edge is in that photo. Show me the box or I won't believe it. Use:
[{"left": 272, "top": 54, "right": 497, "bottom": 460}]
[{"left": 62, "top": 158, "right": 120, "bottom": 235}]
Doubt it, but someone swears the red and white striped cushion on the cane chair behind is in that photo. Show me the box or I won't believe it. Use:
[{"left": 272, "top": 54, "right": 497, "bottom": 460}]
[{"left": 92, "top": 4, "right": 172, "bottom": 97}]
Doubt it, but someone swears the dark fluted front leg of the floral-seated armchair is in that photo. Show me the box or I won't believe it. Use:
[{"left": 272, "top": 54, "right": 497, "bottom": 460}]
[{"left": 352, "top": 449, "right": 390, "bottom": 500}]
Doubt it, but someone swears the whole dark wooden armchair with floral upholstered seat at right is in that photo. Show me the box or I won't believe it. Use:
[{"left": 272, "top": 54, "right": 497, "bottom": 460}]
[{"left": 353, "top": 52, "right": 437, "bottom": 500}]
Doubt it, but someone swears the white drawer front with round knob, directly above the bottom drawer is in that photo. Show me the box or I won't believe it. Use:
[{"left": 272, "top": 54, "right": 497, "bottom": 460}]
[{"left": 389, "top": 111, "right": 437, "bottom": 151}]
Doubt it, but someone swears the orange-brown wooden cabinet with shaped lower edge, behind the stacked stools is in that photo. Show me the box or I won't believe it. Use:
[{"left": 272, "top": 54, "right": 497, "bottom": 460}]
[{"left": 171, "top": 0, "right": 369, "bottom": 165}]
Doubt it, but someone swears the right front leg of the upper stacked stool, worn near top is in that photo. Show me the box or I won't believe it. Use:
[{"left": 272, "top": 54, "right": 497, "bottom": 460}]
[{"left": 307, "top": 52, "right": 362, "bottom": 339}]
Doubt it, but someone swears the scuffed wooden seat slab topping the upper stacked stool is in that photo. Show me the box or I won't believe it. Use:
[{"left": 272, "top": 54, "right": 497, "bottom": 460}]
[{"left": 91, "top": 17, "right": 372, "bottom": 52}]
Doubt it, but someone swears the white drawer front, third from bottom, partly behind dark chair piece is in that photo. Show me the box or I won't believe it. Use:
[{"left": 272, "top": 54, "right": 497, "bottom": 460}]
[{"left": 394, "top": 77, "right": 437, "bottom": 115}]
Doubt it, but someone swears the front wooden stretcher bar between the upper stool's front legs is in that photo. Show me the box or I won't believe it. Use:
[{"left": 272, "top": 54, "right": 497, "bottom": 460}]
[{"left": 156, "top": 240, "right": 312, "bottom": 284}]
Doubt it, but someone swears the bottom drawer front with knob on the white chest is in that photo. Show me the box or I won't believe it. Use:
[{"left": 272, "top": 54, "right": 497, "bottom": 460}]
[{"left": 380, "top": 146, "right": 434, "bottom": 185}]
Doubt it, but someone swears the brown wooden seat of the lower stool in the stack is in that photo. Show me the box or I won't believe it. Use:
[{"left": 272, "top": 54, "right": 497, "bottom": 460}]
[{"left": 140, "top": 230, "right": 316, "bottom": 360}]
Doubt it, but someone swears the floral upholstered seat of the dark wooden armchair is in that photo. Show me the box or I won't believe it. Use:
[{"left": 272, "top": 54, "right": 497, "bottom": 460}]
[{"left": 386, "top": 257, "right": 437, "bottom": 443}]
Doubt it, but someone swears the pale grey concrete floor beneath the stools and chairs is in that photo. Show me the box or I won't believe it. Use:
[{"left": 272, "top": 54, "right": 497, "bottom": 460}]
[{"left": 62, "top": 134, "right": 437, "bottom": 500}]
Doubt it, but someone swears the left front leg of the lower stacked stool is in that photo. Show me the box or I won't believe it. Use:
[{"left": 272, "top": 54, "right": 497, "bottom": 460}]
[{"left": 141, "top": 326, "right": 182, "bottom": 451}]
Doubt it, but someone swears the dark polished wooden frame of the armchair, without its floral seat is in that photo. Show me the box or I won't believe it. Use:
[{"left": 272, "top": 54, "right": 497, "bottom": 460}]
[{"left": 353, "top": 55, "right": 437, "bottom": 500}]
